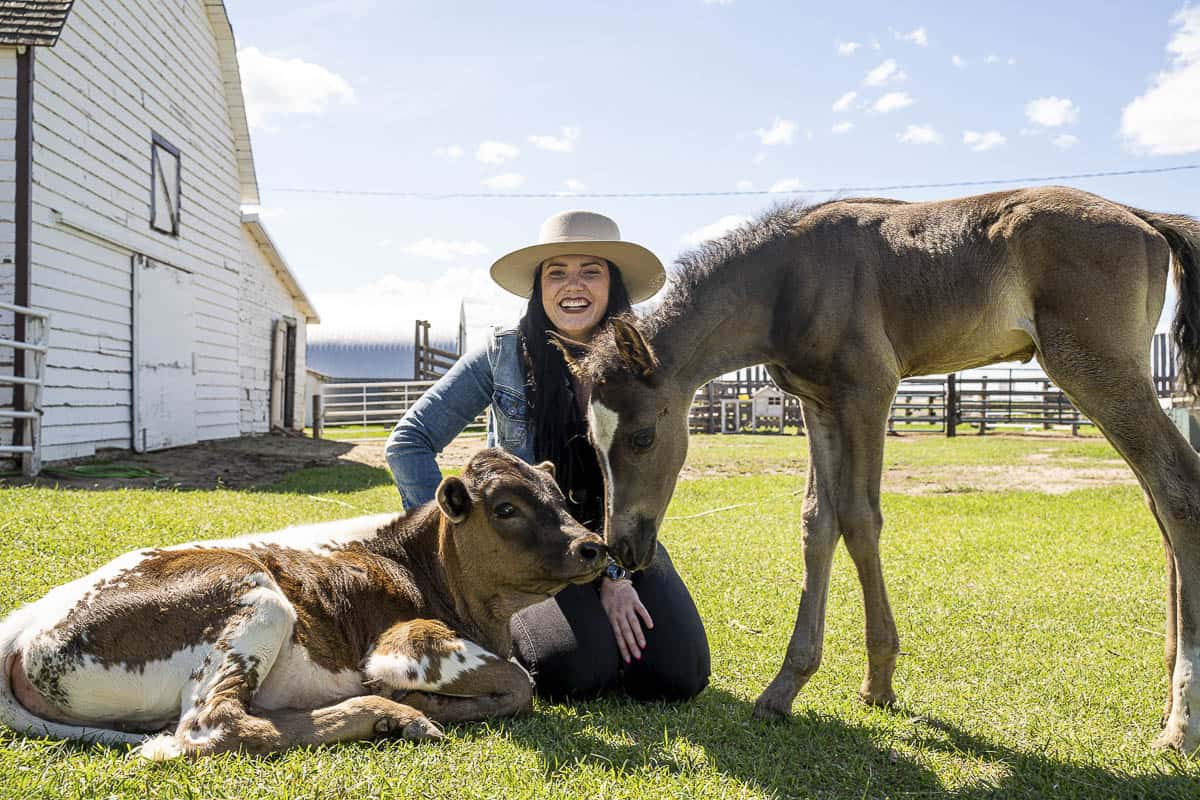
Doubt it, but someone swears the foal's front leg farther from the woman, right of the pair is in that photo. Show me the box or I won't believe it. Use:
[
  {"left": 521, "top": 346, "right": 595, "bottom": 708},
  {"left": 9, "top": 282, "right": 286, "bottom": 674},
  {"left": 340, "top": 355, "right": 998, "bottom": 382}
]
[{"left": 838, "top": 386, "right": 900, "bottom": 705}]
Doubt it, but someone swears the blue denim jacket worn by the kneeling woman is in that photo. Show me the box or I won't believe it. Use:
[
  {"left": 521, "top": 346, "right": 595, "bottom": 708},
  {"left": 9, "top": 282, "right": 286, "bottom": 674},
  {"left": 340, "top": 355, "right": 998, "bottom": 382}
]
[{"left": 384, "top": 329, "right": 534, "bottom": 509}]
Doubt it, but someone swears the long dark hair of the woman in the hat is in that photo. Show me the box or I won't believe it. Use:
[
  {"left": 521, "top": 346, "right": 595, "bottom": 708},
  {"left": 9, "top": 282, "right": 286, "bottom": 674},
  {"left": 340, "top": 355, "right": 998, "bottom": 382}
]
[{"left": 518, "top": 261, "right": 630, "bottom": 488}]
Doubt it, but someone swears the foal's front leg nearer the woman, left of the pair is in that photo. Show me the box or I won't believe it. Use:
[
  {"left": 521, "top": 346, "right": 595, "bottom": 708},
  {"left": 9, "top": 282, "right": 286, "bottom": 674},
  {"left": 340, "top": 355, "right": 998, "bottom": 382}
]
[{"left": 754, "top": 401, "right": 842, "bottom": 720}]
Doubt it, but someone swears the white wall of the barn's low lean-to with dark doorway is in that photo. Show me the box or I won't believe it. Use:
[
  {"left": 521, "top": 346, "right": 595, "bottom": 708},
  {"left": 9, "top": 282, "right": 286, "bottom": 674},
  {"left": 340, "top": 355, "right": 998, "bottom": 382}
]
[{"left": 238, "top": 225, "right": 306, "bottom": 433}]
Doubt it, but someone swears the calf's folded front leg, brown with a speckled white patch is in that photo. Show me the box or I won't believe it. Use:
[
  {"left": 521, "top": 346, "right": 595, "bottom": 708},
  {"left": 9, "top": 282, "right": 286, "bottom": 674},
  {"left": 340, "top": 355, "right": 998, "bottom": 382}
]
[{"left": 362, "top": 619, "right": 533, "bottom": 723}]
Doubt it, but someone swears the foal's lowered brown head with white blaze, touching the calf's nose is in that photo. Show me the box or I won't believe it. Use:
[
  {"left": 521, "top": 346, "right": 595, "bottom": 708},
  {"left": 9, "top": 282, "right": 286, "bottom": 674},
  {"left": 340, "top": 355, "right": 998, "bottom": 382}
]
[{"left": 559, "top": 317, "right": 692, "bottom": 569}]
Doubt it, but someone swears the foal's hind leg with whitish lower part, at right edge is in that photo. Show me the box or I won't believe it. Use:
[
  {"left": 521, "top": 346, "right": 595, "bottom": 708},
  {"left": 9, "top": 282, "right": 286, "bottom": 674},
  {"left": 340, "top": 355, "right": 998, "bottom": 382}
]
[{"left": 1043, "top": 347, "right": 1200, "bottom": 752}]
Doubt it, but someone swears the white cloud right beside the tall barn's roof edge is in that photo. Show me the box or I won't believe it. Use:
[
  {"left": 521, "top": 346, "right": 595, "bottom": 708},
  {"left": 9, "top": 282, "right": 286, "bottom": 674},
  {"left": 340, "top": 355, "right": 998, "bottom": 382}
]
[{"left": 238, "top": 47, "right": 355, "bottom": 130}]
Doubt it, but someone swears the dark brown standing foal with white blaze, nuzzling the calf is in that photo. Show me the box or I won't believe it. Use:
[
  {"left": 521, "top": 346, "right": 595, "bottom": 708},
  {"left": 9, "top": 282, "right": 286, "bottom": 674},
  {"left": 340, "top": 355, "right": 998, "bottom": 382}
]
[{"left": 564, "top": 187, "right": 1200, "bottom": 751}]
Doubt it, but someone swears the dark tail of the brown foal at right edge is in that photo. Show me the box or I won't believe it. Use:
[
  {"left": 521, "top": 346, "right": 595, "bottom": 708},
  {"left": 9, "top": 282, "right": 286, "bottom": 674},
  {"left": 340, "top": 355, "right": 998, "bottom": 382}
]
[{"left": 1129, "top": 209, "right": 1200, "bottom": 397}]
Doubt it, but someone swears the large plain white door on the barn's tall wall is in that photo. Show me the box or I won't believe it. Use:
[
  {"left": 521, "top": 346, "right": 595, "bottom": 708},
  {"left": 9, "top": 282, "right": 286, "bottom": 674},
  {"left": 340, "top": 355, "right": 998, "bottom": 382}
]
[{"left": 133, "top": 255, "right": 197, "bottom": 452}]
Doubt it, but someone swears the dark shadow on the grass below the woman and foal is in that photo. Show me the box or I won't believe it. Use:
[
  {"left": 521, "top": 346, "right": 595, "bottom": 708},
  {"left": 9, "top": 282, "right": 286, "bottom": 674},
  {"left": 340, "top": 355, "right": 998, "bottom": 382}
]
[{"left": 456, "top": 688, "right": 1200, "bottom": 800}]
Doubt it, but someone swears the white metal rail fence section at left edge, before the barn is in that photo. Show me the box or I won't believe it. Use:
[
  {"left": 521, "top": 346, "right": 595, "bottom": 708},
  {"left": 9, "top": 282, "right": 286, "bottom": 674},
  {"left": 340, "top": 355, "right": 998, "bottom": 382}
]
[{"left": 0, "top": 302, "right": 50, "bottom": 477}]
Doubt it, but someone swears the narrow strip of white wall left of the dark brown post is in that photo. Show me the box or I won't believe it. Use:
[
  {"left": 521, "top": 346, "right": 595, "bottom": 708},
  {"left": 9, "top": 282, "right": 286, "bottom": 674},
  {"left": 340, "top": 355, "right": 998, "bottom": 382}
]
[{"left": 0, "top": 47, "right": 17, "bottom": 468}]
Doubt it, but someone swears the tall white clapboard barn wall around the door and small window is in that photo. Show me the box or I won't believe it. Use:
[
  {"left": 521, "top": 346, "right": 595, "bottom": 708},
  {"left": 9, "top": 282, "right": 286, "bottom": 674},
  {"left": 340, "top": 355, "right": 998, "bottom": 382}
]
[{"left": 31, "top": 0, "right": 244, "bottom": 461}]
